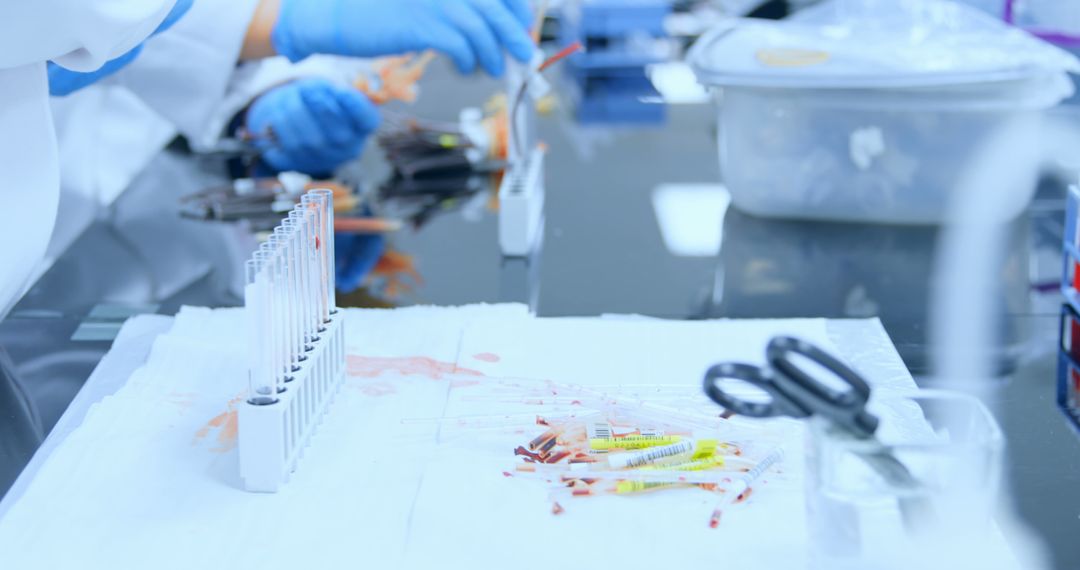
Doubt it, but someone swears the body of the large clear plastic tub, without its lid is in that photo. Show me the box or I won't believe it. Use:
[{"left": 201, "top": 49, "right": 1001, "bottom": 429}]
[{"left": 713, "top": 76, "right": 1069, "bottom": 223}]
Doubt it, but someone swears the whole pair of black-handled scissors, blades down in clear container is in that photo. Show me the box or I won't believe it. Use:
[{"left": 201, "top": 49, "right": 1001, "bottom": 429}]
[{"left": 705, "top": 337, "right": 932, "bottom": 528}]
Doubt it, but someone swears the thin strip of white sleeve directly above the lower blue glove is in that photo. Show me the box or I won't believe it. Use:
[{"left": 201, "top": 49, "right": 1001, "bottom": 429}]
[{"left": 189, "top": 55, "right": 372, "bottom": 149}]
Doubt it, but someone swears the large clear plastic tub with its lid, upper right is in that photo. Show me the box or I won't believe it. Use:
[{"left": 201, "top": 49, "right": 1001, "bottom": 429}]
[{"left": 688, "top": 7, "right": 1080, "bottom": 225}]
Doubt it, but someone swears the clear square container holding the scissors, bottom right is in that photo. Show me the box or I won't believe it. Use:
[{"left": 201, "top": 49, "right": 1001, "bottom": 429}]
[{"left": 808, "top": 390, "right": 1004, "bottom": 570}]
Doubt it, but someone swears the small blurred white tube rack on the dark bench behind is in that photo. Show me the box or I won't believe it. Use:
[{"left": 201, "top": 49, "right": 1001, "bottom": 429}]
[{"left": 499, "top": 147, "right": 544, "bottom": 257}]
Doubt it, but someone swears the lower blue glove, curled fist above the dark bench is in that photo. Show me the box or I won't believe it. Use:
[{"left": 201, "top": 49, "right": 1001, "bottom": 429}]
[{"left": 246, "top": 79, "right": 380, "bottom": 175}]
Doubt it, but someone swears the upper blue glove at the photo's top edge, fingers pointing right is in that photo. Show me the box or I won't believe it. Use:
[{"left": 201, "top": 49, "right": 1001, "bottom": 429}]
[{"left": 271, "top": 0, "right": 534, "bottom": 76}]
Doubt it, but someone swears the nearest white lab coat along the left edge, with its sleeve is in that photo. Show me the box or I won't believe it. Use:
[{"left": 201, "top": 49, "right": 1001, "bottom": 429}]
[{"left": 0, "top": 0, "right": 174, "bottom": 318}]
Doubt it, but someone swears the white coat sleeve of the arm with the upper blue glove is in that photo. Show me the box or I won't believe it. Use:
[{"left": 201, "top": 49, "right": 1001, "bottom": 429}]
[{"left": 111, "top": 0, "right": 258, "bottom": 147}]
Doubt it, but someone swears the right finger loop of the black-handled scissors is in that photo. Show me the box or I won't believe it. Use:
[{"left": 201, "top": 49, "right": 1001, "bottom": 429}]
[{"left": 766, "top": 337, "right": 878, "bottom": 436}]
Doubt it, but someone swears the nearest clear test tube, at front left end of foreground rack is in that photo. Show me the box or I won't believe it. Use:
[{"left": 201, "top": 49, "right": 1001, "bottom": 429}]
[{"left": 244, "top": 257, "right": 278, "bottom": 406}]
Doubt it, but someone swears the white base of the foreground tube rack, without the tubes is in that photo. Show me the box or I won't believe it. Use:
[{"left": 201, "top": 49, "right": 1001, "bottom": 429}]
[{"left": 238, "top": 311, "right": 346, "bottom": 492}]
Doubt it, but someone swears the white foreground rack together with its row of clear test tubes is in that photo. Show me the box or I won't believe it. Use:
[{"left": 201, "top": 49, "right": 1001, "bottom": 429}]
[{"left": 238, "top": 189, "right": 345, "bottom": 492}]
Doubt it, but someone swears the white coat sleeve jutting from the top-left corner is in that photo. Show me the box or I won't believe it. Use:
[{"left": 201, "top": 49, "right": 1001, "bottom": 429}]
[{"left": 0, "top": 0, "right": 175, "bottom": 71}]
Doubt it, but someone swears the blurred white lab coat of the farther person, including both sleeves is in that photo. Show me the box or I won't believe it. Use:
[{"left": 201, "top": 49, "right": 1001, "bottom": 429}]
[{"left": 46, "top": 0, "right": 367, "bottom": 270}]
